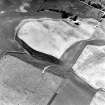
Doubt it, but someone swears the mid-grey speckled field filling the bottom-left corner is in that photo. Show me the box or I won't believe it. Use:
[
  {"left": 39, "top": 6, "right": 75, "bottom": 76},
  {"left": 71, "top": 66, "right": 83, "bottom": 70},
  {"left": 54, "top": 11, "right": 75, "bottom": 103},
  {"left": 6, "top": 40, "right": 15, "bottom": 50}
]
[{"left": 0, "top": 55, "right": 62, "bottom": 105}]
